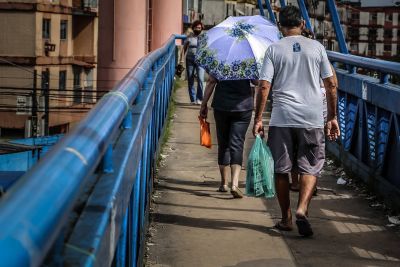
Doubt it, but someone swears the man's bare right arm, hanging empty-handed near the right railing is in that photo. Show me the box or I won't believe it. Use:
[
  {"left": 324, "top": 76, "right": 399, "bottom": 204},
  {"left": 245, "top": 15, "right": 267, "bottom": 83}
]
[{"left": 323, "top": 71, "right": 340, "bottom": 140}]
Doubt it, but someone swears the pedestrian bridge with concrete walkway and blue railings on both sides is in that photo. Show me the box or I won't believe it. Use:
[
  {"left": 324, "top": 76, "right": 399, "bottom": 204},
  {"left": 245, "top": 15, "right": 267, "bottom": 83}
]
[{"left": 0, "top": 2, "right": 400, "bottom": 267}]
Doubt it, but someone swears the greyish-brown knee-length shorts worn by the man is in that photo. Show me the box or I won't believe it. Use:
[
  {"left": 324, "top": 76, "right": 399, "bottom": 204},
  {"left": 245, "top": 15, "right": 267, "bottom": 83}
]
[{"left": 268, "top": 126, "right": 325, "bottom": 176}]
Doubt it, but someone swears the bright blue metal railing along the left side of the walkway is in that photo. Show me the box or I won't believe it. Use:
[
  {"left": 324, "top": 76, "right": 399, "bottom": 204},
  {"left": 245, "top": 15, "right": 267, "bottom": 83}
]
[{"left": 0, "top": 36, "right": 184, "bottom": 266}]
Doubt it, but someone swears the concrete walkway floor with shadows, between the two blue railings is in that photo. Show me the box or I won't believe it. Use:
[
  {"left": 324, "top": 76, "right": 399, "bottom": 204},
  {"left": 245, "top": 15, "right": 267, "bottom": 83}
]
[{"left": 146, "top": 82, "right": 400, "bottom": 267}]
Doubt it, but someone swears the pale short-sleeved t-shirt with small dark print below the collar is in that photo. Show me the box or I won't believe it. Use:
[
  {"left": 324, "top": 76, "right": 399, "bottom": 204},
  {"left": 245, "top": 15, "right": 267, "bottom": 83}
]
[{"left": 260, "top": 35, "right": 333, "bottom": 128}]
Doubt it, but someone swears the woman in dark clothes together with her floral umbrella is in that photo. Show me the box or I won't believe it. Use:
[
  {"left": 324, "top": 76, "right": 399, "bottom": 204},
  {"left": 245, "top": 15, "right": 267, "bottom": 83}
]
[{"left": 196, "top": 16, "right": 279, "bottom": 198}]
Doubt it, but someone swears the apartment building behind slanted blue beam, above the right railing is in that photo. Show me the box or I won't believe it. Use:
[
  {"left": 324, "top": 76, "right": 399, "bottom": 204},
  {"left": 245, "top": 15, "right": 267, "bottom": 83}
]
[{"left": 308, "top": 1, "right": 400, "bottom": 61}]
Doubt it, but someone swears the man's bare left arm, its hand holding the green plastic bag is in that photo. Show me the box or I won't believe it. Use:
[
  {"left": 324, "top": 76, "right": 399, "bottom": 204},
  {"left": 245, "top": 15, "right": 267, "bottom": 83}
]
[{"left": 253, "top": 80, "right": 271, "bottom": 136}]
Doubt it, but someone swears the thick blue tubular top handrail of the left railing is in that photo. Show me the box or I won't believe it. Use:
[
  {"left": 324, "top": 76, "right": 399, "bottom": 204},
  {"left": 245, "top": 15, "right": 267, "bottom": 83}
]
[{"left": 0, "top": 35, "right": 185, "bottom": 266}]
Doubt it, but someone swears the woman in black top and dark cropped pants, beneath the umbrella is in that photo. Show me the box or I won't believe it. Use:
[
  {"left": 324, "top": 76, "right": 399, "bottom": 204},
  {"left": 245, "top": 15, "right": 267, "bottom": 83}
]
[{"left": 200, "top": 75, "right": 254, "bottom": 198}]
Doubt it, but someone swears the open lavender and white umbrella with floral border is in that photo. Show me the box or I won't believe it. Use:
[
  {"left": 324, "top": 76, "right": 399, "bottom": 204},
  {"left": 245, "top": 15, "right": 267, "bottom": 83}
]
[{"left": 196, "top": 15, "right": 279, "bottom": 80}]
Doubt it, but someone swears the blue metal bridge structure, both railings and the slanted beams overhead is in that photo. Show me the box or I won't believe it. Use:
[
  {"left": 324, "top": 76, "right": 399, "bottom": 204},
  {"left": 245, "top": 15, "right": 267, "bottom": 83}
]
[{"left": 0, "top": 0, "right": 400, "bottom": 267}]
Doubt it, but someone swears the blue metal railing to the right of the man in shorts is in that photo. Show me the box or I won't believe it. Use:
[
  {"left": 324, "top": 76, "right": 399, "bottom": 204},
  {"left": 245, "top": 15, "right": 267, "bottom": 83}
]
[{"left": 327, "top": 51, "right": 400, "bottom": 208}]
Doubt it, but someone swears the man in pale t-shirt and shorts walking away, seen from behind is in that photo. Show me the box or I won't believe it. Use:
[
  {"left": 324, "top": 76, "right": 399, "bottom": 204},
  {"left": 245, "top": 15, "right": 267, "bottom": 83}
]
[{"left": 253, "top": 6, "right": 340, "bottom": 236}]
